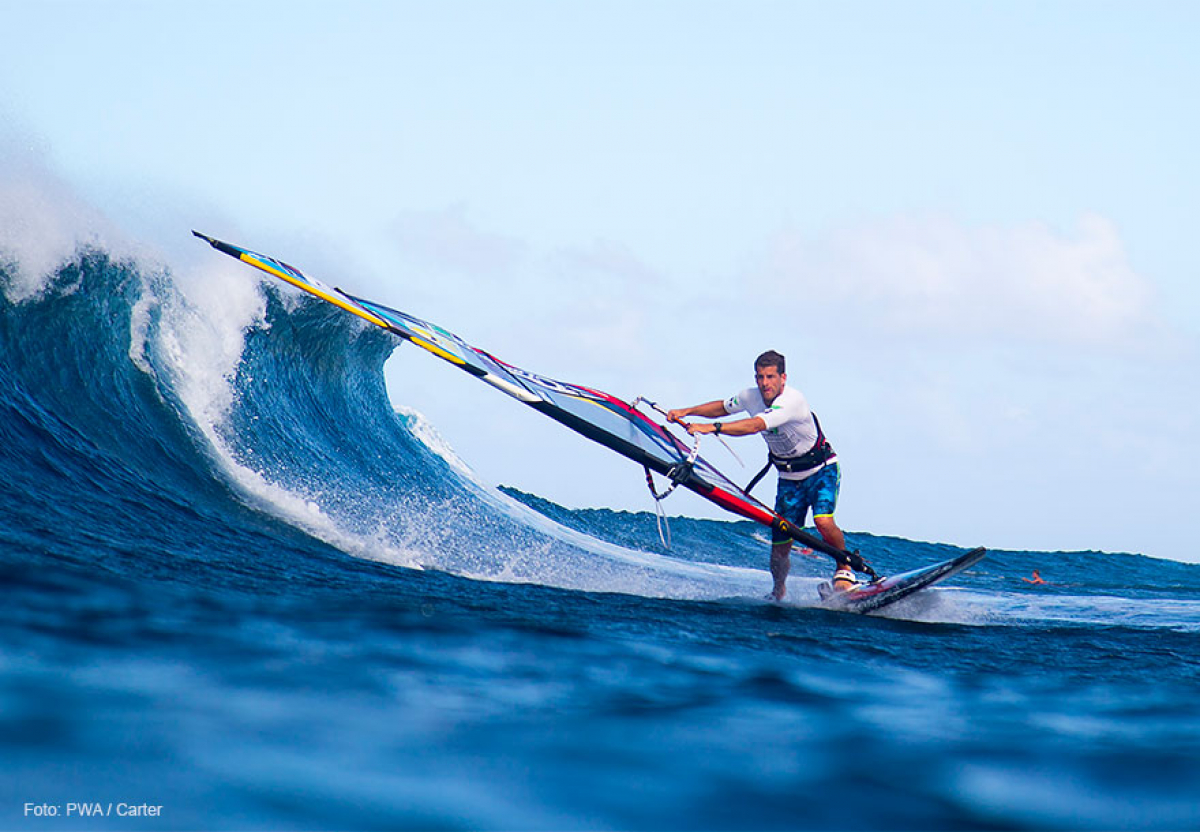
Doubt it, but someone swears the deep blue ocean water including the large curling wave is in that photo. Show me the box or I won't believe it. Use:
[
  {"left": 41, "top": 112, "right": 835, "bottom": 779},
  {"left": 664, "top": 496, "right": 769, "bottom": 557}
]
[{"left": 0, "top": 251, "right": 1200, "bottom": 830}]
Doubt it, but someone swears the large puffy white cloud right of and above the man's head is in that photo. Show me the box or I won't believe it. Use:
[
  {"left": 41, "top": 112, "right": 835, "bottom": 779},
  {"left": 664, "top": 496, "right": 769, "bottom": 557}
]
[{"left": 758, "top": 215, "right": 1163, "bottom": 347}]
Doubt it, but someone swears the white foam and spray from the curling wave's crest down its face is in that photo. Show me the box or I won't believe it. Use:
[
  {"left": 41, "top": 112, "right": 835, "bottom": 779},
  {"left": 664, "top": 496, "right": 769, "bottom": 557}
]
[{"left": 0, "top": 157, "right": 412, "bottom": 571}]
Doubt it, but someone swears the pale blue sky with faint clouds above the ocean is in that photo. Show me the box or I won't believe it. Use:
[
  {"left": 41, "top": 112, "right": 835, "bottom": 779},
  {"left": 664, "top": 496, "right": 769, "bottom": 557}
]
[{"left": 0, "top": 0, "right": 1200, "bottom": 561}]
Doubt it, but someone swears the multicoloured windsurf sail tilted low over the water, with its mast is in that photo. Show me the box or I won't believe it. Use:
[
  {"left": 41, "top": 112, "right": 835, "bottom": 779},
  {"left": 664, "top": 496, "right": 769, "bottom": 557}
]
[{"left": 192, "top": 231, "right": 875, "bottom": 577}]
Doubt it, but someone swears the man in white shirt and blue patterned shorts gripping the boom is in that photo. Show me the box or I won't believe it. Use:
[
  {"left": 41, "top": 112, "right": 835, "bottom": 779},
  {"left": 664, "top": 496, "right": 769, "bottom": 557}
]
[{"left": 667, "top": 349, "right": 857, "bottom": 600}]
